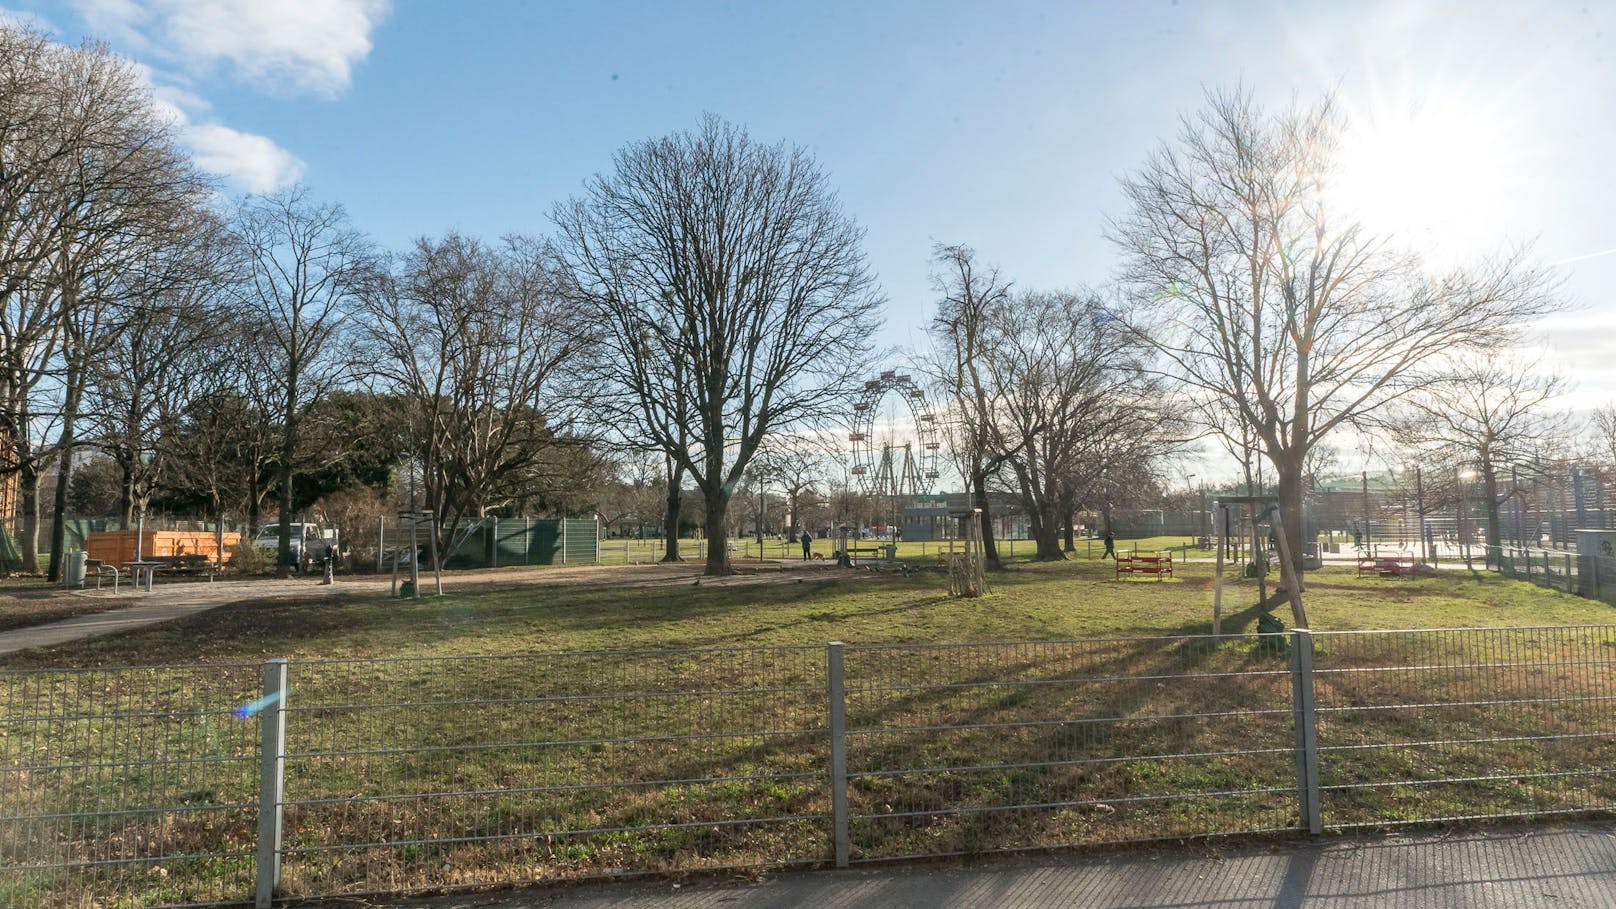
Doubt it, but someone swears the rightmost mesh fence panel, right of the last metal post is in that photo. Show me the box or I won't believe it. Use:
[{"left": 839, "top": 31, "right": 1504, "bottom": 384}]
[{"left": 1314, "top": 626, "right": 1616, "bottom": 827}]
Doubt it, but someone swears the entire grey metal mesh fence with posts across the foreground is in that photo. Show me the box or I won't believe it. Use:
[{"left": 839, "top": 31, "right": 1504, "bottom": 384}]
[{"left": 0, "top": 626, "right": 1616, "bottom": 907}]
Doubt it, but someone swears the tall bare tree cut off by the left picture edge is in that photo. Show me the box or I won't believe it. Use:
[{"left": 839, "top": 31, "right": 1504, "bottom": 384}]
[{"left": 0, "top": 26, "right": 205, "bottom": 571}]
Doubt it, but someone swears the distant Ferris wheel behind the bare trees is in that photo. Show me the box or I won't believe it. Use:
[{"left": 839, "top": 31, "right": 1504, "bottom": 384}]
[{"left": 848, "top": 369, "right": 942, "bottom": 497}]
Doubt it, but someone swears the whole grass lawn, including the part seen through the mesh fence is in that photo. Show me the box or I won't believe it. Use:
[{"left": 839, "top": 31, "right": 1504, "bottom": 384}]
[{"left": 0, "top": 560, "right": 1616, "bottom": 906}]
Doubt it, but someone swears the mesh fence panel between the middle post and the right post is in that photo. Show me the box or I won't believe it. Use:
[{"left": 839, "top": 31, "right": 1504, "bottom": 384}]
[{"left": 847, "top": 637, "right": 1296, "bottom": 862}]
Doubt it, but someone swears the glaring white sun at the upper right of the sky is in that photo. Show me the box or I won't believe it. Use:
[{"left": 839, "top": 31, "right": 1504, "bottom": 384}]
[{"left": 1333, "top": 93, "right": 1521, "bottom": 260}]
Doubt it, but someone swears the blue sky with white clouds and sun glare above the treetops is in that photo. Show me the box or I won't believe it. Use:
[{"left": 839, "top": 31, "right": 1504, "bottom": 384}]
[{"left": 12, "top": 0, "right": 1616, "bottom": 436}]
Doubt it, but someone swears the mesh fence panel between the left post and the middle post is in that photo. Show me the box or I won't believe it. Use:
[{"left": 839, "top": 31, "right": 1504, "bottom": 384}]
[{"left": 283, "top": 647, "right": 829, "bottom": 894}]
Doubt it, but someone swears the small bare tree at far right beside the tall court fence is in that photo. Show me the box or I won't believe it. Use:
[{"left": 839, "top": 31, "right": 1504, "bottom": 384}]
[{"left": 1391, "top": 356, "right": 1571, "bottom": 561}]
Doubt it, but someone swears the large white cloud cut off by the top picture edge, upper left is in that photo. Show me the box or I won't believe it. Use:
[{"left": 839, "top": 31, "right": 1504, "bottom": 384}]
[{"left": 73, "top": 0, "right": 389, "bottom": 97}]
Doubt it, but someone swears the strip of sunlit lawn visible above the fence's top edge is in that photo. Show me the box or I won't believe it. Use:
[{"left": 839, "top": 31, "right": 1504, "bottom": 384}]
[{"left": 6, "top": 560, "right": 1616, "bottom": 666}]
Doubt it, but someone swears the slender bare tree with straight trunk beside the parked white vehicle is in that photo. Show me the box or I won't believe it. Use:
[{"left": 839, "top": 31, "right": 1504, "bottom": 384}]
[{"left": 234, "top": 186, "right": 372, "bottom": 577}]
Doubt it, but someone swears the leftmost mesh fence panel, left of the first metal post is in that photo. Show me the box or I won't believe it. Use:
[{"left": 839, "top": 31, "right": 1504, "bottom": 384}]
[{"left": 0, "top": 665, "right": 260, "bottom": 907}]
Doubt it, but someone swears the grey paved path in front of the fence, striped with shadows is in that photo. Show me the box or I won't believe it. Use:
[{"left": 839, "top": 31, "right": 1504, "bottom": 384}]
[{"left": 371, "top": 823, "right": 1616, "bottom": 909}]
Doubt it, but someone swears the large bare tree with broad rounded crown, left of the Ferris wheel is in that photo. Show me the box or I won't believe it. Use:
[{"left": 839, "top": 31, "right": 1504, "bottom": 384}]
[{"left": 554, "top": 116, "right": 879, "bottom": 574}]
